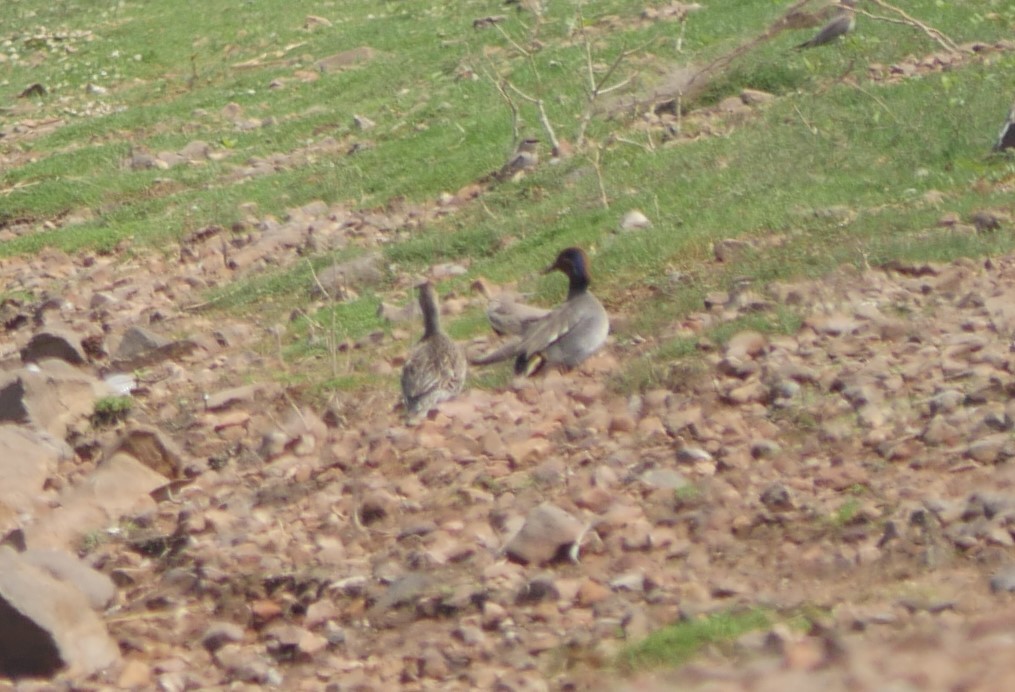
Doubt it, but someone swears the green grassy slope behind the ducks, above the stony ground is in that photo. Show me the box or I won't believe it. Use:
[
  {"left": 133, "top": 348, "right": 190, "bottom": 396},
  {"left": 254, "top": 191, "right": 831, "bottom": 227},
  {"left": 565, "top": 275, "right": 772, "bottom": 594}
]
[{"left": 0, "top": 0, "right": 1015, "bottom": 387}]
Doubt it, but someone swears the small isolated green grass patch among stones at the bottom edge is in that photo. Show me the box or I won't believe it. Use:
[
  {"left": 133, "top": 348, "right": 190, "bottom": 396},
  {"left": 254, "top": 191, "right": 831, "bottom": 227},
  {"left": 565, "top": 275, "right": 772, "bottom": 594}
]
[{"left": 617, "top": 609, "right": 771, "bottom": 672}]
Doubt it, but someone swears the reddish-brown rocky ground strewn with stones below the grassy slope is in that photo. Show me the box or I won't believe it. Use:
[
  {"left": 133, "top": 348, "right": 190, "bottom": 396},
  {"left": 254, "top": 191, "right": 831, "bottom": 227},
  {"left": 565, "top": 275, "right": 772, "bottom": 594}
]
[{"left": 0, "top": 169, "right": 1015, "bottom": 690}]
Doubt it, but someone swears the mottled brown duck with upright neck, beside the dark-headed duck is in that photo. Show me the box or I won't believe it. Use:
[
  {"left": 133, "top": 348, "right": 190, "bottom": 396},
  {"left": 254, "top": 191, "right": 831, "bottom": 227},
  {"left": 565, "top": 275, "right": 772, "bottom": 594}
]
[{"left": 402, "top": 281, "right": 469, "bottom": 422}]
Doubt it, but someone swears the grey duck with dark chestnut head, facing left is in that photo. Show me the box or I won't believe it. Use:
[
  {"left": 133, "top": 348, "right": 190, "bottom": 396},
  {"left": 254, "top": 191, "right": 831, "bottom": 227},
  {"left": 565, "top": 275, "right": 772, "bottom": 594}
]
[{"left": 473, "top": 248, "right": 610, "bottom": 376}]
